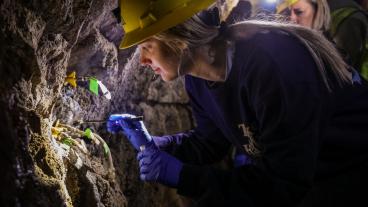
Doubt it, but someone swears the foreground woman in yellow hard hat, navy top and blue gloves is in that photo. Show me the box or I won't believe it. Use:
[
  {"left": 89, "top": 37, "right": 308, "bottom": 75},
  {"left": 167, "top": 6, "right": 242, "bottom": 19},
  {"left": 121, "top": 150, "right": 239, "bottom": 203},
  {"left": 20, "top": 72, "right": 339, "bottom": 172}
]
[{"left": 107, "top": 0, "right": 368, "bottom": 206}]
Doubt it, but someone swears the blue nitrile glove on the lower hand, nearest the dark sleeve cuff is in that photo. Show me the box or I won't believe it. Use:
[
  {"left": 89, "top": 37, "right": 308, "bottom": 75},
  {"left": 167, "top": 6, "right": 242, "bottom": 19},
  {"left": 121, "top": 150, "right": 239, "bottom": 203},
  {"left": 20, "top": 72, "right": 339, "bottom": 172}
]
[{"left": 137, "top": 142, "right": 183, "bottom": 187}]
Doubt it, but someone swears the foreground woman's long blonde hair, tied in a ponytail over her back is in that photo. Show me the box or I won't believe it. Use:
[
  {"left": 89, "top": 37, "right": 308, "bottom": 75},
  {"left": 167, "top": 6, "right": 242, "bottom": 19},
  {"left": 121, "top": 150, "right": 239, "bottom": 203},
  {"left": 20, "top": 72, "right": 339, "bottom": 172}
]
[{"left": 154, "top": 4, "right": 352, "bottom": 89}]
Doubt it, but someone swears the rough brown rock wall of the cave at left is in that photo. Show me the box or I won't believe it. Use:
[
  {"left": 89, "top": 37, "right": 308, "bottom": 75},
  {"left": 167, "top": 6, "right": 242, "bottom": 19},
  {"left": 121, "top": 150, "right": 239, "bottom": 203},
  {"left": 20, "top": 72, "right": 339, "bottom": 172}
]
[{"left": 0, "top": 0, "right": 193, "bottom": 206}]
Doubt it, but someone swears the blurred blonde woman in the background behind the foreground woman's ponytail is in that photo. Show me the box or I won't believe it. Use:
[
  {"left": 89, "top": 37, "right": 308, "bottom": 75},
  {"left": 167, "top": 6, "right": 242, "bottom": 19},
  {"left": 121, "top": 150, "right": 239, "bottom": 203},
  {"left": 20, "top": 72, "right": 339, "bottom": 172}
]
[{"left": 278, "top": 0, "right": 368, "bottom": 80}]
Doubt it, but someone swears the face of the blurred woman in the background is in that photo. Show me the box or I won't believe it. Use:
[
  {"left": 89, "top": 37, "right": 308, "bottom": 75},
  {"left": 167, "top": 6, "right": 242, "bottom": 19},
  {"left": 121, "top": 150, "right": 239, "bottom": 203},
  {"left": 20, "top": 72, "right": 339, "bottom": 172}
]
[{"left": 290, "top": 0, "right": 315, "bottom": 28}]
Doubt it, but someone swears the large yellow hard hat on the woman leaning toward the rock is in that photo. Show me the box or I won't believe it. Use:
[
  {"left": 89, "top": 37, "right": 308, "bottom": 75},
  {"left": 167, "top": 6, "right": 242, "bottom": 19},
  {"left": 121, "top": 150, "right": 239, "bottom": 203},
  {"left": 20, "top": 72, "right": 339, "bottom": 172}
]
[{"left": 120, "top": 0, "right": 216, "bottom": 49}]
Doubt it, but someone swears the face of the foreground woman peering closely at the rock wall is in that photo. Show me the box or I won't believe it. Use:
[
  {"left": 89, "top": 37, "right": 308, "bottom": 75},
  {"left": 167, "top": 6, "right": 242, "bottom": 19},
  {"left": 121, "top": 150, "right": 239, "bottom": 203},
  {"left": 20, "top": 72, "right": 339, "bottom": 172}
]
[{"left": 138, "top": 38, "right": 179, "bottom": 81}]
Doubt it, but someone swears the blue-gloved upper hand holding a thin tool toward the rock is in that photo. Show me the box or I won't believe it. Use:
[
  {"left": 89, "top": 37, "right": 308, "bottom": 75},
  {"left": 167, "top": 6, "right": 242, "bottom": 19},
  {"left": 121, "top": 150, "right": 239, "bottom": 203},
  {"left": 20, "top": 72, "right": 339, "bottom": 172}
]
[{"left": 107, "top": 114, "right": 152, "bottom": 150}]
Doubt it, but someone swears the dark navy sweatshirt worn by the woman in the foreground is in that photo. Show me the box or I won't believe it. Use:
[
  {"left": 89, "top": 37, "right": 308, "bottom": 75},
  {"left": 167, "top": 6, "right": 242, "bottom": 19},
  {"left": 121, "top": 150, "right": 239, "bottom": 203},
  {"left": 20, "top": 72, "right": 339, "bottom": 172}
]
[{"left": 165, "top": 29, "right": 368, "bottom": 206}]
